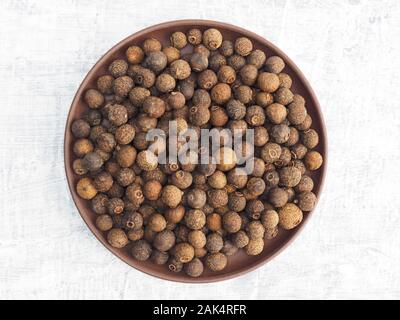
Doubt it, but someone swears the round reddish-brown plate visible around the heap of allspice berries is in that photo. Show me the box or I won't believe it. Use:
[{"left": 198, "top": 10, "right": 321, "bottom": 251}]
[{"left": 64, "top": 20, "right": 327, "bottom": 283}]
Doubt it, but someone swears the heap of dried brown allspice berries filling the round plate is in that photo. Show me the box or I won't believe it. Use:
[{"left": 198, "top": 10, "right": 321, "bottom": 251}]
[{"left": 70, "top": 28, "right": 323, "bottom": 277}]
